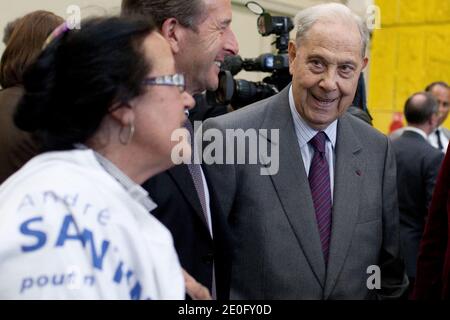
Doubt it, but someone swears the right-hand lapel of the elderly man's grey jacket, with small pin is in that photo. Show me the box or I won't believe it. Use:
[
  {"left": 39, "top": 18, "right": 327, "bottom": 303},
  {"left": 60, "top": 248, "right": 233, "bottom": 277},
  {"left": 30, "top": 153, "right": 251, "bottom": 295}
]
[{"left": 324, "top": 115, "right": 365, "bottom": 299}]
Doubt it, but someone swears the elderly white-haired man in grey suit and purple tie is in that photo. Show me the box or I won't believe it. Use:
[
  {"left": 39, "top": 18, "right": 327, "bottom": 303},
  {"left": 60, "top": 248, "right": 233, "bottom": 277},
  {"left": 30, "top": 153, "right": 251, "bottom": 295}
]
[{"left": 203, "top": 4, "right": 408, "bottom": 299}]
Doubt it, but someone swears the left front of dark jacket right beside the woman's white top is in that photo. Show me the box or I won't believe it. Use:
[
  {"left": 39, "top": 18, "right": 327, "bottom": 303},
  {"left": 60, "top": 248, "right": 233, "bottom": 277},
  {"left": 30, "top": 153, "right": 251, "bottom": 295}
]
[{"left": 142, "top": 165, "right": 214, "bottom": 290}]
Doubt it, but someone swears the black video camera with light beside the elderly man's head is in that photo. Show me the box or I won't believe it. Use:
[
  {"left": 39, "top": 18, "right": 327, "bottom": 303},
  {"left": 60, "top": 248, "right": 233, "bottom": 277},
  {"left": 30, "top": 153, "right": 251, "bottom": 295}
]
[{"left": 206, "top": 1, "right": 294, "bottom": 109}]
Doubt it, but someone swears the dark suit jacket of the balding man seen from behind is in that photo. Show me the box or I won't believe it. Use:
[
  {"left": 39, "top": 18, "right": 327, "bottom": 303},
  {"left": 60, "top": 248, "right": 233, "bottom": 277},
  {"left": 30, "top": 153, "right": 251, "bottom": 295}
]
[{"left": 392, "top": 130, "right": 444, "bottom": 278}]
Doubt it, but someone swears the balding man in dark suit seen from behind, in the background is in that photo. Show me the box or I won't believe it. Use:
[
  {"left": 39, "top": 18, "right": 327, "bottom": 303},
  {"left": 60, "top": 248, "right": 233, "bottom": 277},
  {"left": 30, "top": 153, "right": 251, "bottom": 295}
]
[{"left": 392, "top": 92, "right": 444, "bottom": 294}]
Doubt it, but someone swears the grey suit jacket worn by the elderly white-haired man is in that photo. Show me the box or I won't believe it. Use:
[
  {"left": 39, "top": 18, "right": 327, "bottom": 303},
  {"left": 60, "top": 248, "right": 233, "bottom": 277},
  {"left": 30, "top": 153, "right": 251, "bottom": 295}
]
[{"left": 203, "top": 88, "right": 408, "bottom": 299}]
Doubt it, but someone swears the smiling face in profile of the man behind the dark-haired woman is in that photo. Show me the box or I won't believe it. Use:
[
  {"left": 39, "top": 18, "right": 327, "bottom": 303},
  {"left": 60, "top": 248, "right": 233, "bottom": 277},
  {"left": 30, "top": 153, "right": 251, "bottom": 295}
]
[{"left": 176, "top": 0, "right": 239, "bottom": 93}]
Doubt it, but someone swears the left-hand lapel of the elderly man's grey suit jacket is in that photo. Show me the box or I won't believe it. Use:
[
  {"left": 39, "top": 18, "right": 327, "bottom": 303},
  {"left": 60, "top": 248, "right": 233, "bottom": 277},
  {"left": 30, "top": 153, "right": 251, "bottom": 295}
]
[{"left": 262, "top": 86, "right": 325, "bottom": 287}]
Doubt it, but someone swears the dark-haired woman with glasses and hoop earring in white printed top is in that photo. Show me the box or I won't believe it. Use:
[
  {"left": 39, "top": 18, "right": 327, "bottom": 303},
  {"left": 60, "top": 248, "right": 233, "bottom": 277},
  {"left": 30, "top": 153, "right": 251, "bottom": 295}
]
[{"left": 0, "top": 17, "right": 198, "bottom": 299}]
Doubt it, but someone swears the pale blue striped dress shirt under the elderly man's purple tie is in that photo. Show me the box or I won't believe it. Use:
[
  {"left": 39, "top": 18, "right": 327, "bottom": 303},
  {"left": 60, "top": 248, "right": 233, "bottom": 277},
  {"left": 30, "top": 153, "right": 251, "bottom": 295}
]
[{"left": 289, "top": 86, "right": 338, "bottom": 200}]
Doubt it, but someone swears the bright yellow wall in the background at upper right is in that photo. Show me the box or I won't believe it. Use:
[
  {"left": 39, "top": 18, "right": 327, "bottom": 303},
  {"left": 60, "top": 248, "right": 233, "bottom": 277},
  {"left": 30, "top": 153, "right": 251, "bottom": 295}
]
[{"left": 368, "top": 0, "right": 450, "bottom": 133}]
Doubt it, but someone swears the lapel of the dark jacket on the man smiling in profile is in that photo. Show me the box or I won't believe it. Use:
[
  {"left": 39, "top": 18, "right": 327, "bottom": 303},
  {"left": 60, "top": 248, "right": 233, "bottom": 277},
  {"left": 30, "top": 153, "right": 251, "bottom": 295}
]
[{"left": 168, "top": 164, "right": 209, "bottom": 230}]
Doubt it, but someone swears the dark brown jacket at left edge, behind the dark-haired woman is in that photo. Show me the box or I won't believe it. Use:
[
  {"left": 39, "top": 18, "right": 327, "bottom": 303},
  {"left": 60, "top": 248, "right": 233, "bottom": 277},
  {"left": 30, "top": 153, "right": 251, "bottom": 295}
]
[{"left": 0, "top": 87, "right": 39, "bottom": 183}]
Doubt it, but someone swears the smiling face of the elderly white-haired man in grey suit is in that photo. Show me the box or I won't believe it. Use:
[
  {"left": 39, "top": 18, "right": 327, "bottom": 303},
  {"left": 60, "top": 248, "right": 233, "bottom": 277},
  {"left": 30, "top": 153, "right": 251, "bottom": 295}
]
[{"left": 289, "top": 21, "right": 367, "bottom": 130}]
